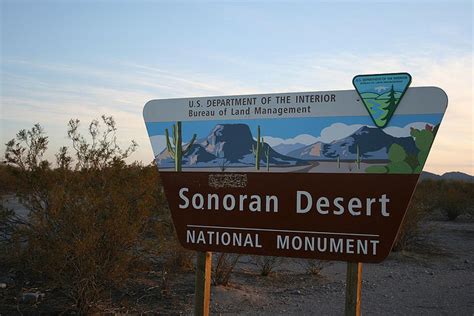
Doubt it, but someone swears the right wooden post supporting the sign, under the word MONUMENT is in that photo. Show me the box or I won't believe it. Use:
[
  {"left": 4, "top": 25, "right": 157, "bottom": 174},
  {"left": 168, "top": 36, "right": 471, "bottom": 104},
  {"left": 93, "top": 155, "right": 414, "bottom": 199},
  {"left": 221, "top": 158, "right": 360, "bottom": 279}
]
[{"left": 344, "top": 262, "right": 362, "bottom": 316}]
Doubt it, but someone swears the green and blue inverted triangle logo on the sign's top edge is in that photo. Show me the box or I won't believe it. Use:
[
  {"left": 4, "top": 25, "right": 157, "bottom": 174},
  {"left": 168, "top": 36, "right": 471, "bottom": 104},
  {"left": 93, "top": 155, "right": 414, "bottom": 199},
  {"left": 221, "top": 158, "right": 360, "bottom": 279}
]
[{"left": 352, "top": 72, "right": 411, "bottom": 128}]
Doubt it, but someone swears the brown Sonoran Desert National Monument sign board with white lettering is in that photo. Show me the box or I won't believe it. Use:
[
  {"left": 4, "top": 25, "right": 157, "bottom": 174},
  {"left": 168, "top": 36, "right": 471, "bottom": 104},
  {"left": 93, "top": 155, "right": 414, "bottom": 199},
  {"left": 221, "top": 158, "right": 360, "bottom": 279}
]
[{"left": 144, "top": 86, "right": 447, "bottom": 262}]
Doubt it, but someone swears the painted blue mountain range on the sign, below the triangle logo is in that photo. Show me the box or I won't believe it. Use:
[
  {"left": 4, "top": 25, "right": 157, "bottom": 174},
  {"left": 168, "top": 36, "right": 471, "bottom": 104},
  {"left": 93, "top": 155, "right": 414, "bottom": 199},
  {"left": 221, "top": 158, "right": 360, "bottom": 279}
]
[{"left": 287, "top": 126, "right": 418, "bottom": 160}]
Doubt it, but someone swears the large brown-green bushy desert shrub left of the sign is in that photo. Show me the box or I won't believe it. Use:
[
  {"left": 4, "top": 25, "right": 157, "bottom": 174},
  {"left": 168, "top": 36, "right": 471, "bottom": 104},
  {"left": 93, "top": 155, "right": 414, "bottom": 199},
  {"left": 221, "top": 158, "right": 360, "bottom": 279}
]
[{"left": 1, "top": 116, "right": 160, "bottom": 313}]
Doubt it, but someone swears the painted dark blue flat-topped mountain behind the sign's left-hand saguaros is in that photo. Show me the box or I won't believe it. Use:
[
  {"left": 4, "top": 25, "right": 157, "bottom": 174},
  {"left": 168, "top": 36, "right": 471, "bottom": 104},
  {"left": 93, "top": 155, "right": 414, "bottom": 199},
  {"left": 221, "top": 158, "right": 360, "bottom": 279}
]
[{"left": 155, "top": 124, "right": 306, "bottom": 168}]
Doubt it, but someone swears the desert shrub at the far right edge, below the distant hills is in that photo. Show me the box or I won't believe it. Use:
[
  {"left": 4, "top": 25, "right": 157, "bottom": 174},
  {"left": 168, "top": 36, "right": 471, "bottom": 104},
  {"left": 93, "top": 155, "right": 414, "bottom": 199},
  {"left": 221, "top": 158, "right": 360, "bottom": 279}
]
[{"left": 436, "top": 181, "right": 474, "bottom": 221}]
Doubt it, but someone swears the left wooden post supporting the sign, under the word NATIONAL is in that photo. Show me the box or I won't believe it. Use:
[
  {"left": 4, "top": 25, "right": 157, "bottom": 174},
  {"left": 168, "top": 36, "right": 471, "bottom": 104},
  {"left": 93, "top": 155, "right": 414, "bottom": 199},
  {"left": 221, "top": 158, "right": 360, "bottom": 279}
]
[{"left": 194, "top": 251, "right": 212, "bottom": 316}]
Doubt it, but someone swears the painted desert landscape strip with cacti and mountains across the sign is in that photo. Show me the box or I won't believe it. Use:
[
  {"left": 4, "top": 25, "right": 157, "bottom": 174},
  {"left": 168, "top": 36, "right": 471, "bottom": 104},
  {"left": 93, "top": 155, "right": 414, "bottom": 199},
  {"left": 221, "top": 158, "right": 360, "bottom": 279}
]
[{"left": 147, "top": 114, "right": 442, "bottom": 173}]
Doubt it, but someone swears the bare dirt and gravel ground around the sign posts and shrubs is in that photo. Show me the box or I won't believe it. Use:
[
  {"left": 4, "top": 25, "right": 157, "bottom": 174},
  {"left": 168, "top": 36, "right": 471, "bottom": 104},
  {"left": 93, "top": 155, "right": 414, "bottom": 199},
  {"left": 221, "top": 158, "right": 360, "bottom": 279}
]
[{"left": 0, "top": 219, "right": 474, "bottom": 315}]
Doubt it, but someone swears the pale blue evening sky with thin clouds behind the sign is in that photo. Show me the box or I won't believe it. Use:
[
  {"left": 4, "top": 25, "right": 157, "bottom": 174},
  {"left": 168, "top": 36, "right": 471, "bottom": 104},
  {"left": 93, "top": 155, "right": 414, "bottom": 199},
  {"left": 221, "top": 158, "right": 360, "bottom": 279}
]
[{"left": 0, "top": 0, "right": 474, "bottom": 174}]
